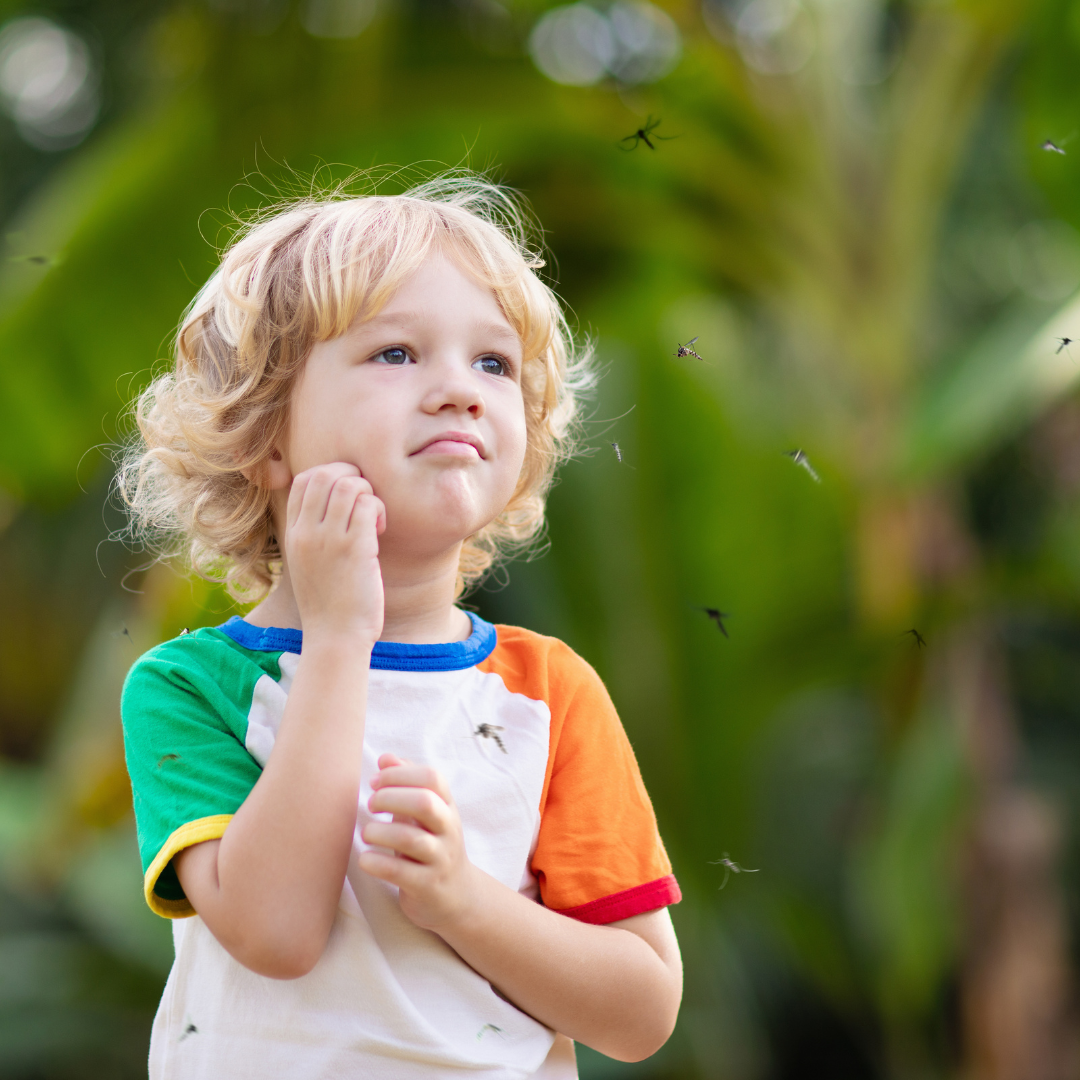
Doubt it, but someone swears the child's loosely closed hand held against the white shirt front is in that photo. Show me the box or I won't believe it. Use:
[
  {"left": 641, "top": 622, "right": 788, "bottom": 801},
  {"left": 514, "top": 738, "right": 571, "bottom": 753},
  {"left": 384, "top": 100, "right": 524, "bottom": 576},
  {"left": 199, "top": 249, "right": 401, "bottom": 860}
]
[{"left": 360, "top": 754, "right": 478, "bottom": 933}]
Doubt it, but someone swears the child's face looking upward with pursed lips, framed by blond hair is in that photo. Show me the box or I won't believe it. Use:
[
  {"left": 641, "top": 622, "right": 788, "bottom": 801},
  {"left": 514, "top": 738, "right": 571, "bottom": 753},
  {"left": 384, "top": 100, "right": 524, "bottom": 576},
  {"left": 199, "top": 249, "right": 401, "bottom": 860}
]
[{"left": 271, "top": 255, "right": 526, "bottom": 556}]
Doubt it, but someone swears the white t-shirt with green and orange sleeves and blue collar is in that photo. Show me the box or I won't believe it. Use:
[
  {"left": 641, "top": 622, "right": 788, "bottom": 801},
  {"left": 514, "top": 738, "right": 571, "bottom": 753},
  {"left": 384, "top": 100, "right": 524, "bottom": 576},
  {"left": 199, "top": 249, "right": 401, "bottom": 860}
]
[{"left": 123, "top": 616, "right": 680, "bottom": 1080}]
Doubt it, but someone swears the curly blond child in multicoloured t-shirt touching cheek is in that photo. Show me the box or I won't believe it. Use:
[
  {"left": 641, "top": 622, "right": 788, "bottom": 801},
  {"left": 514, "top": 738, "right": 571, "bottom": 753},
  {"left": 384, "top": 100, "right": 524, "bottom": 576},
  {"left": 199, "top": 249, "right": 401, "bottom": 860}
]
[{"left": 120, "top": 177, "right": 681, "bottom": 1080}]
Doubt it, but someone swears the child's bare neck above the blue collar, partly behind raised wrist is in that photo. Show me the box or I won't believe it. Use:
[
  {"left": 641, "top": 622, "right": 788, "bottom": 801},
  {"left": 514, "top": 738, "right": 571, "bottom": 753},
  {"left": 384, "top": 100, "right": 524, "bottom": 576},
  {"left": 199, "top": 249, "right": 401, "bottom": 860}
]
[{"left": 245, "top": 552, "right": 472, "bottom": 645}]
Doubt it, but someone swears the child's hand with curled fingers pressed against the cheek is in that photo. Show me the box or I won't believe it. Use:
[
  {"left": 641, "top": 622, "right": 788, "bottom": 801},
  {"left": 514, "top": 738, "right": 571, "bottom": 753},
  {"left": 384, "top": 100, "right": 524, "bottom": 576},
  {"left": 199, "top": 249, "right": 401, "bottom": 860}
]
[{"left": 284, "top": 461, "right": 387, "bottom": 645}]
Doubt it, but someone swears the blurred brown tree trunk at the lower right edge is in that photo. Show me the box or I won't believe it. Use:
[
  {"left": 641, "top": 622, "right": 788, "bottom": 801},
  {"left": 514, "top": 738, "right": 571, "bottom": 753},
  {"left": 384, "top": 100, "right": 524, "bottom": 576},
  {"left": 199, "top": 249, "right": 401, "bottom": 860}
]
[{"left": 949, "top": 625, "right": 1080, "bottom": 1080}]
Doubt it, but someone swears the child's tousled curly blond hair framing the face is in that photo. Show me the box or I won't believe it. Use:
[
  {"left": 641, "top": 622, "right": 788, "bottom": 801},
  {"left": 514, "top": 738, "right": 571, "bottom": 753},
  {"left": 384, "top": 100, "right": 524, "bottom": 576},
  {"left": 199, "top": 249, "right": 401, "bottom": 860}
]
[{"left": 117, "top": 172, "right": 592, "bottom": 600}]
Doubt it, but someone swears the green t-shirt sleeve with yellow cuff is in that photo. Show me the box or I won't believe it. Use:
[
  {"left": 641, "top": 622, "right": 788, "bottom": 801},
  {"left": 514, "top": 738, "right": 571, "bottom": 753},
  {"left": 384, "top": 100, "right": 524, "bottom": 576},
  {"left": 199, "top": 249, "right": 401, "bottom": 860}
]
[{"left": 121, "top": 631, "right": 270, "bottom": 918}]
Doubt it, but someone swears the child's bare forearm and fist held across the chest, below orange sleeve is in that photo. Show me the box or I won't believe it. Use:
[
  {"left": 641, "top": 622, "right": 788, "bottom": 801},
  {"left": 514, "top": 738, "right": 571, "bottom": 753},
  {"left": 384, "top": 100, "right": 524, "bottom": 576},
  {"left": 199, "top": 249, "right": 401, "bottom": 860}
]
[{"left": 360, "top": 754, "right": 683, "bottom": 1061}]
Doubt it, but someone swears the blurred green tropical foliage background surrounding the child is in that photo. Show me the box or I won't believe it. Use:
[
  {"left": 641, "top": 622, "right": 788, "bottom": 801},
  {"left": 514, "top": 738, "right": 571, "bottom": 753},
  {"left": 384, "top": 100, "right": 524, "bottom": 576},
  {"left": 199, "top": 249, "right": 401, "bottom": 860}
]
[{"left": 0, "top": 0, "right": 1080, "bottom": 1080}]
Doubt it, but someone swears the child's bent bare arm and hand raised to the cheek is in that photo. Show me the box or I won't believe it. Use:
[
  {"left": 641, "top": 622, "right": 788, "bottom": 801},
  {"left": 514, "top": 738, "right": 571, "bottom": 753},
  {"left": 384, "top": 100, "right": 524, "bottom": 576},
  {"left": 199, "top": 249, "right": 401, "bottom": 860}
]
[{"left": 175, "top": 463, "right": 383, "bottom": 978}]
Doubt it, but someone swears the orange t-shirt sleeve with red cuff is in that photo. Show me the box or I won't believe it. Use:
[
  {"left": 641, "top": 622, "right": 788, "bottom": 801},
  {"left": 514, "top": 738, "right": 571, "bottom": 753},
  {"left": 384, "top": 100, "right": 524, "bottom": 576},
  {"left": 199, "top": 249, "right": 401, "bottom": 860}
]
[{"left": 480, "top": 626, "right": 681, "bottom": 923}]
